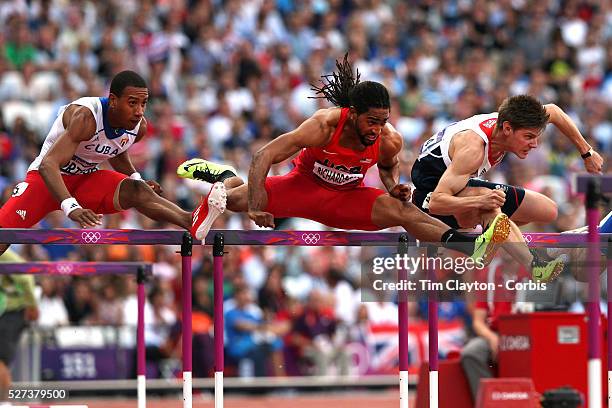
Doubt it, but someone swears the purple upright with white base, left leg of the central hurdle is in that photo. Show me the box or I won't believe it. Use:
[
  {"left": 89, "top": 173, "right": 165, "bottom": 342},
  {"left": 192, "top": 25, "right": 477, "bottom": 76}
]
[{"left": 213, "top": 233, "right": 225, "bottom": 408}]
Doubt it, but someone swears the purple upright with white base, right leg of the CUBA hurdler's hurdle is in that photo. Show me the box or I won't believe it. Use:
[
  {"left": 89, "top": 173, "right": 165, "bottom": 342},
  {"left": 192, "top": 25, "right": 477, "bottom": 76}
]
[{"left": 181, "top": 232, "right": 193, "bottom": 408}]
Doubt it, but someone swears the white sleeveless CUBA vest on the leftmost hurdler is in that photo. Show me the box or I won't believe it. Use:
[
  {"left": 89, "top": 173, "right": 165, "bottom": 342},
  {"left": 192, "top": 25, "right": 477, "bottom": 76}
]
[{"left": 28, "top": 97, "right": 140, "bottom": 175}]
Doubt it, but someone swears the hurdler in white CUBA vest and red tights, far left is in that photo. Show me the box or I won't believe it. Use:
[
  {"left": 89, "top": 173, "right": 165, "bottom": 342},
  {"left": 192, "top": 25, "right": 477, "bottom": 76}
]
[{"left": 0, "top": 71, "right": 208, "bottom": 253}]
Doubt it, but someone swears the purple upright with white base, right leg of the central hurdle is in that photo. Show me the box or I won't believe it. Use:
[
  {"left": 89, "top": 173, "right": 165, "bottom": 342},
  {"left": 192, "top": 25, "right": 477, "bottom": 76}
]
[{"left": 397, "top": 234, "right": 408, "bottom": 408}]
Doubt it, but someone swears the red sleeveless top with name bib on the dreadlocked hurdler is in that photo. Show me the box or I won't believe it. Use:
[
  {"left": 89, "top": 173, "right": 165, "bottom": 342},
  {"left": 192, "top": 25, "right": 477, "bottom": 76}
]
[{"left": 293, "top": 108, "right": 380, "bottom": 190}]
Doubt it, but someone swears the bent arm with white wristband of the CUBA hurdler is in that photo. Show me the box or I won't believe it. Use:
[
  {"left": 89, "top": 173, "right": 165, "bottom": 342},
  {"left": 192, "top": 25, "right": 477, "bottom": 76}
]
[{"left": 38, "top": 105, "right": 101, "bottom": 227}]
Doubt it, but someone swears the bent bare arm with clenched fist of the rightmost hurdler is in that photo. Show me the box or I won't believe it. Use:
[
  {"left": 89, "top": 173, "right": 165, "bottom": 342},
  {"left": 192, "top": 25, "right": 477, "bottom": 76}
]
[{"left": 429, "top": 131, "right": 505, "bottom": 215}]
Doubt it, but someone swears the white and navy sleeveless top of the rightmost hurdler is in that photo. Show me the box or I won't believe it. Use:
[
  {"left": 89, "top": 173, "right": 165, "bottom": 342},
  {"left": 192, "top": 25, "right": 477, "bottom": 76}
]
[{"left": 412, "top": 112, "right": 503, "bottom": 191}]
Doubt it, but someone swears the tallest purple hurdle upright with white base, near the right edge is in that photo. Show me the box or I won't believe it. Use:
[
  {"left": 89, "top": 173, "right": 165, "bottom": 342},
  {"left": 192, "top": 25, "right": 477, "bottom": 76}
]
[{"left": 585, "top": 179, "right": 602, "bottom": 408}]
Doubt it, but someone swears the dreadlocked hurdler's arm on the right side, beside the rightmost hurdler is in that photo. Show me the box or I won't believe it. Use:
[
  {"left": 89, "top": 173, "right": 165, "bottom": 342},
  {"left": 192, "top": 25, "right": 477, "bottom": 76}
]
[{"left": 376, "top": 124, "right": 410, "bottom": 201}]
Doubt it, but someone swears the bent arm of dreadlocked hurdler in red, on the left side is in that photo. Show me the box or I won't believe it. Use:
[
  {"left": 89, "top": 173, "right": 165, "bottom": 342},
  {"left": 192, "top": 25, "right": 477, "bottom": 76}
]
[{"left": 248, "top": 109, "right": 332, "bottom": 227}]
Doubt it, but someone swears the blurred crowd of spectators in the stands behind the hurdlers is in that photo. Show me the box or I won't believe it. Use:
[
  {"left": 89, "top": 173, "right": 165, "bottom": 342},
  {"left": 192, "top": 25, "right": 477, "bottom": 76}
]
[{"left": 0, "top": 0, "right": 612, "bottom": 375}]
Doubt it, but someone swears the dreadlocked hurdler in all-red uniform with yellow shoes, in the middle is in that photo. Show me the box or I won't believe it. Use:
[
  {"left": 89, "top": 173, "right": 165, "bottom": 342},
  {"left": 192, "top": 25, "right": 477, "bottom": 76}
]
[{"left": 177, "top": 57, "right": 509, "bottom": 263}]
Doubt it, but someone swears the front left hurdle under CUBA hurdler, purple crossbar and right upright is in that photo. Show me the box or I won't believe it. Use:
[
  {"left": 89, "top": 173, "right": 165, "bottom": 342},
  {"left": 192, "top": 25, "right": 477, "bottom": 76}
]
[{"left": 0, "top": 228, "right": 193, "bottom": 408}]
